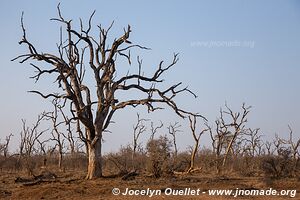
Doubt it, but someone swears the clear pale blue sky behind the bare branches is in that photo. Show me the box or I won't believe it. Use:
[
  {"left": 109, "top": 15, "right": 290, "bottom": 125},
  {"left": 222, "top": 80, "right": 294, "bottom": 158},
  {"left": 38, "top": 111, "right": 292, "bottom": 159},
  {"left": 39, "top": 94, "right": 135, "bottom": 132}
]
[{"left": 0, "top": 0, "right": 300, "bottom": 152}]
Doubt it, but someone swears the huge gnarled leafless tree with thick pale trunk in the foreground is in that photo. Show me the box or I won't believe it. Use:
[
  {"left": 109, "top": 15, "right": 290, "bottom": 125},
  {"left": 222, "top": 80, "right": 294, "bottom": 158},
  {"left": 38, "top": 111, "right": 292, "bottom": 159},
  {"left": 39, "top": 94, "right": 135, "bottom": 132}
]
[{"left": 13, "top": 5, "right": 202, "bottom": 179}]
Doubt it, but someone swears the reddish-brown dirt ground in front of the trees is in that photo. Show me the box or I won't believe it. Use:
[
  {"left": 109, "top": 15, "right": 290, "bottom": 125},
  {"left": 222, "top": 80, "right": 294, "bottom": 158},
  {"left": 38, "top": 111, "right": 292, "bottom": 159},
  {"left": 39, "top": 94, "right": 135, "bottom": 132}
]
[{"left": 0, "top": 171, "right": 300, "bottom": 200}]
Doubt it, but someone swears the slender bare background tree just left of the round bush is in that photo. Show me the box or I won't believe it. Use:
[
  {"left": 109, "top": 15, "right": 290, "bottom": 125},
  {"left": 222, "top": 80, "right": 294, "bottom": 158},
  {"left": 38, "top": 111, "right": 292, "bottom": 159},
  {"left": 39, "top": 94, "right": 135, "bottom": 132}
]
[{"left": 132, "top": 113, "right": 148, "bottom": 170}]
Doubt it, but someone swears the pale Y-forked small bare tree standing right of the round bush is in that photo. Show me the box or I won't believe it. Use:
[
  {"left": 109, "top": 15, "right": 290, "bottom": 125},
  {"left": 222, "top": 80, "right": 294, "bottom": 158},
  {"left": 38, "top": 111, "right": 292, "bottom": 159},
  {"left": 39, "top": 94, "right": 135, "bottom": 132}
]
[{"left": 187, "top": 116, "right": 208, "bottom": 173}]
